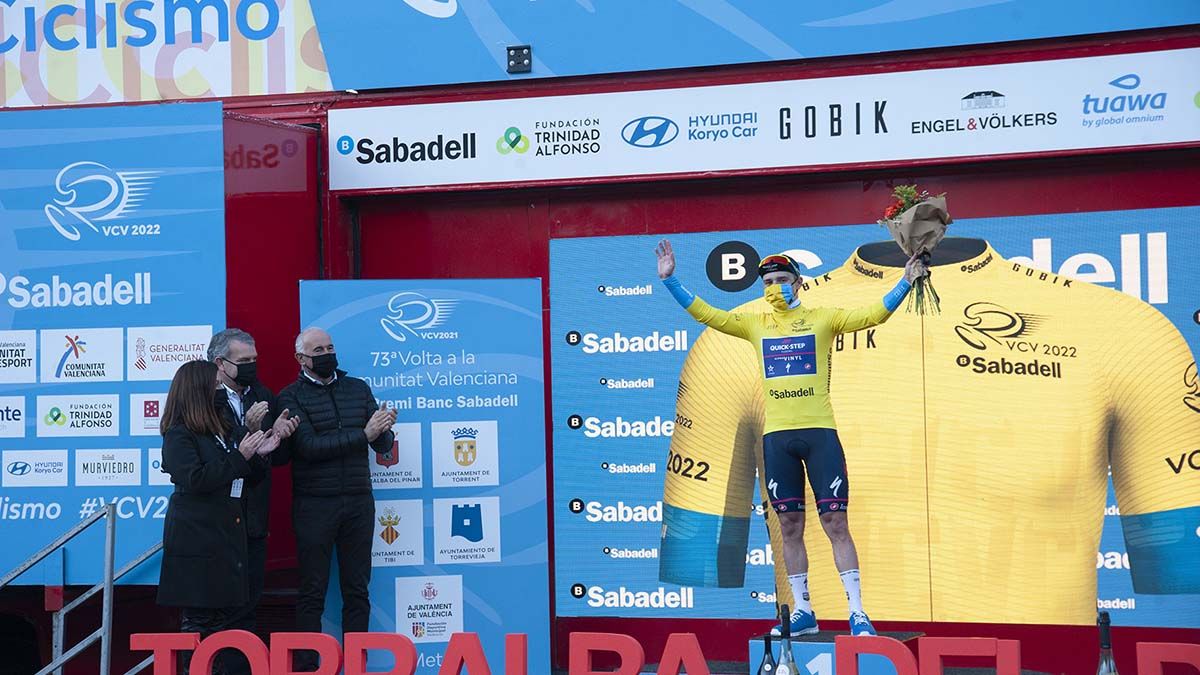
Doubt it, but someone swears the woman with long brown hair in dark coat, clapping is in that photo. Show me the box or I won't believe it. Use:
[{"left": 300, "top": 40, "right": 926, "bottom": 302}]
[{"left": 158, "top": 362, "right": 278, "bottom": 667}]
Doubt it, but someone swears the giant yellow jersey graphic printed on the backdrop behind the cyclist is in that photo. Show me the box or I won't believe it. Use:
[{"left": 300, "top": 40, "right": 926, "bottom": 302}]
[{"left": 660, "top": 243, "right": 1200, "bottom": 625}]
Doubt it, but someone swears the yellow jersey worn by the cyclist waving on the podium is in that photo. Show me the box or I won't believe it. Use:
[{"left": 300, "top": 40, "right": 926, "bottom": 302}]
[{"left": 688, "top": 294, "right": 892, "bottom": 434}]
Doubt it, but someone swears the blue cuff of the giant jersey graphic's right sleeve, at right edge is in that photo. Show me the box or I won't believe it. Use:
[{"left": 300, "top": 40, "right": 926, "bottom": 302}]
[{"left": 1121, "top": 507, "right": 1200, "bottom": 595}]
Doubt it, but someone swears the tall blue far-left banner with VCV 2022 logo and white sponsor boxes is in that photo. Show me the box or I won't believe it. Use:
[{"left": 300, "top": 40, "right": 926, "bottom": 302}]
[{"left": 0, "top": 102, "right": 224, "bottom": 585}]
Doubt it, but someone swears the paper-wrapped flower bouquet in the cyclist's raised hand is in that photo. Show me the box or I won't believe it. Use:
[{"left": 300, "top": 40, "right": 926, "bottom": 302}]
[{"left": 878, "top": 185, "right": 954, "bottom": 315}]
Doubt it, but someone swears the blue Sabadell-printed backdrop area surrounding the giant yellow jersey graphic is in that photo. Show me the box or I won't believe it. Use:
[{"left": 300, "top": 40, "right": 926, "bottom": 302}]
[{"left": 551, "top": 208, "right": 1200, "bottom": 626}]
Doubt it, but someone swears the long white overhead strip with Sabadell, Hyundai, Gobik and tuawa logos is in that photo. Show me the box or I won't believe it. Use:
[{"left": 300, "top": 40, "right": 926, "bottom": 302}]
[{"left": 329, "top": 49, "right": 1200, "bottom": 190}]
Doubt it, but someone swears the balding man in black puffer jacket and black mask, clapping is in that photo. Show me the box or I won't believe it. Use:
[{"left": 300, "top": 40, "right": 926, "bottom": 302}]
[{"left": 278, "top": 328, "right": 396, "bottom": 670}]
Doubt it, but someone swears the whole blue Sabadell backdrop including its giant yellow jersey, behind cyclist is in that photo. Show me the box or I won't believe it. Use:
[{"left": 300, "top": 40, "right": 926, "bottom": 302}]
[{"left": 549, "top": 206, "right": 1200, "bottom": 627}]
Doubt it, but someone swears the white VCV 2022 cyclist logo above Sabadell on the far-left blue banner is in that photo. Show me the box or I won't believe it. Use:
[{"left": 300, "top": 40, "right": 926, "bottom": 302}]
[{"left": 43, "top": 162, "right": 162, "bottom": 241}]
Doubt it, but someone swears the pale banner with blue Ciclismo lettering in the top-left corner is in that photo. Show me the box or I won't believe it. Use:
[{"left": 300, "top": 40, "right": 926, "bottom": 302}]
[{"left": 0, "top": 0, "right": 330, "bottom": 108}]
